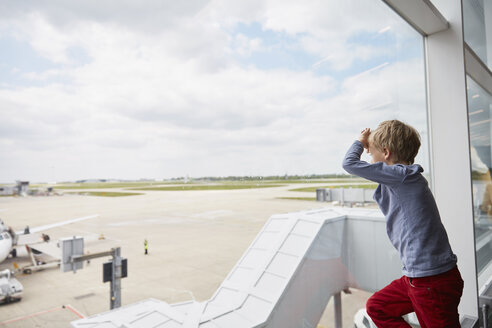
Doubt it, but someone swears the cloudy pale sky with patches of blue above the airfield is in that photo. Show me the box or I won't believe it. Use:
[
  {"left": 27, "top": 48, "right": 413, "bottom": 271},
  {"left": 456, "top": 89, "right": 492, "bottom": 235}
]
[{"left": 0, "top": 0, "right": 426, "bottom": 182}]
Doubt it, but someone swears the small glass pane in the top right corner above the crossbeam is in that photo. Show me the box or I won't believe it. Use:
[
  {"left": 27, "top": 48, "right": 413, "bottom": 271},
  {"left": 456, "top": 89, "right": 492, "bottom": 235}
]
[{"left": 463, "top": 0, "right": 492, "bottom": 68}]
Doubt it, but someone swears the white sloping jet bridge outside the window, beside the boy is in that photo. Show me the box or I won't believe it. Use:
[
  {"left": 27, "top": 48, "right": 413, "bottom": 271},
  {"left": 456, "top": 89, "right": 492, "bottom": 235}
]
[{"left": 71, "top": 208, "right": 401, "bottom": 328}]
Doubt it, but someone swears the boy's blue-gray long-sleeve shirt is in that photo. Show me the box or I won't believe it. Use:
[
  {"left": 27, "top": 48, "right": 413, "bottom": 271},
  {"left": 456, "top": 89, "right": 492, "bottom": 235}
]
[{"left": 343, "top": 141, "right": 457, "bottom": 278}]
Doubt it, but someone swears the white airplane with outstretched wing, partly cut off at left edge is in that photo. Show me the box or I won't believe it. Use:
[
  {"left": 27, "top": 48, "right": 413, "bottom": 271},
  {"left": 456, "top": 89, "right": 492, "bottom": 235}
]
[{"left": 0, "top": 214, "right": 99, "bottom": 263}]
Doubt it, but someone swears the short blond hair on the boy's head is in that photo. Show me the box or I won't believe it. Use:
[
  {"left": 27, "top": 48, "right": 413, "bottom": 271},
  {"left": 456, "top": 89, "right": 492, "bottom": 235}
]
[{"left": 371, "top": 120, "right": 420, "bottom": 164}]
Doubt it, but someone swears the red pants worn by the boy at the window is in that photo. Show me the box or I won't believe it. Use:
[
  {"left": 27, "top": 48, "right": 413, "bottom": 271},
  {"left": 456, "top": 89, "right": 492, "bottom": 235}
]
[{"left": 366, "top": 267, "right": 463, "bottom": 328}]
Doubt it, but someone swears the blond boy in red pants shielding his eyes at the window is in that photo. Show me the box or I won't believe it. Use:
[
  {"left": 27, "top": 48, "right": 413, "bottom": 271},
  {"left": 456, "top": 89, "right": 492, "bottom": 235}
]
[{"left": 343, "top": 120, "right": 463, "bottom": 328}]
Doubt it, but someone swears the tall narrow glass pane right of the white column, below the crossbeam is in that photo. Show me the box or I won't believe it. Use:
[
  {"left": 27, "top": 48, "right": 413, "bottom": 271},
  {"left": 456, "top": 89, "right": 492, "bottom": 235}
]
[{"left": 467, "top": 77, "right": 492, "bottom": 275}]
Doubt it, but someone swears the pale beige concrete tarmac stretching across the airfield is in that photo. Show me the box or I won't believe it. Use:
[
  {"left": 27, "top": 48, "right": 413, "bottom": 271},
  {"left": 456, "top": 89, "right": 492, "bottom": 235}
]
[{"left": 0, "top": 184, "right": 370, "bottom": 328}]
